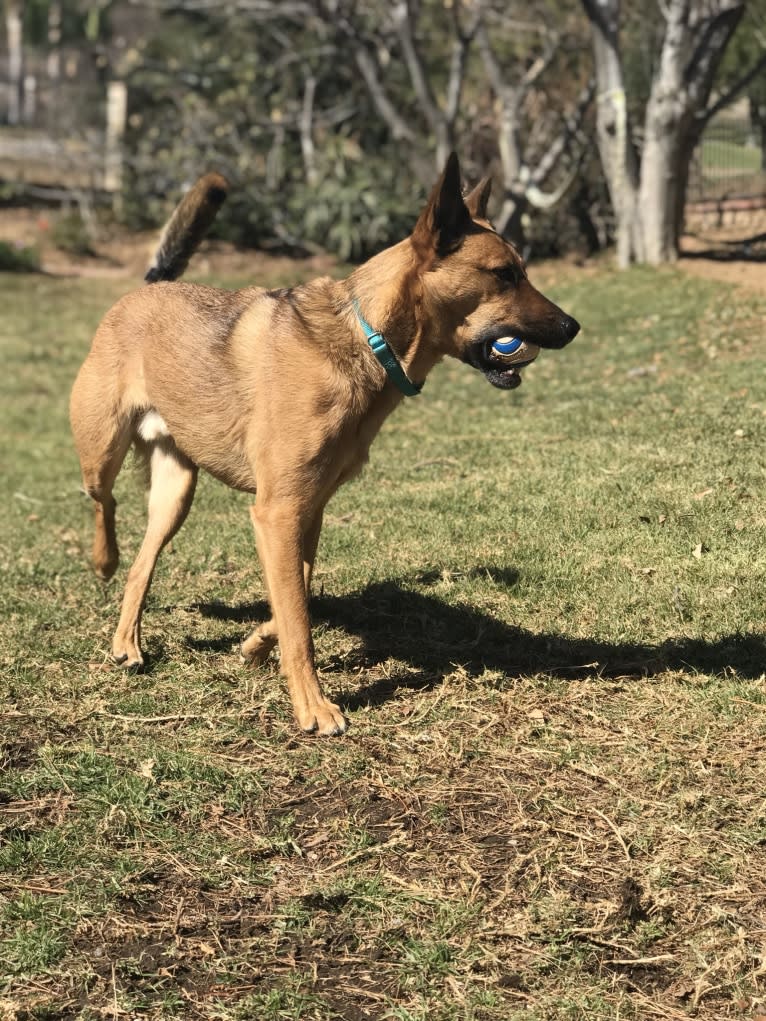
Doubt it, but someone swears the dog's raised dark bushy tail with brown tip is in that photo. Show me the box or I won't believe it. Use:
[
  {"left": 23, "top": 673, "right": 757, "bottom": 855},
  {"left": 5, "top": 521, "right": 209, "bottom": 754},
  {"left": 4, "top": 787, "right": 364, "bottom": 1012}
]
[{"left": 144, "top": 174, "right": 229, "bottom": 284}]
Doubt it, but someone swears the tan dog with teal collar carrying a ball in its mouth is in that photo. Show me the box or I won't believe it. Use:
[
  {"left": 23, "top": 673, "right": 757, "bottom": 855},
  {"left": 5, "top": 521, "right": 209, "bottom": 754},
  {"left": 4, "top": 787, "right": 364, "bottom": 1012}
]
[{"left": 70, "top": 153, "right": 579, "bottom": 735}]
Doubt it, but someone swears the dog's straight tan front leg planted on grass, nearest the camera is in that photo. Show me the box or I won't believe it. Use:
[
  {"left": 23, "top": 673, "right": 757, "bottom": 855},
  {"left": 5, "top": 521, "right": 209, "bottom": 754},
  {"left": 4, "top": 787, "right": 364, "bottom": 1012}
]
[{"left": 250, "top": 499, "right": 346, "bottom": 735}]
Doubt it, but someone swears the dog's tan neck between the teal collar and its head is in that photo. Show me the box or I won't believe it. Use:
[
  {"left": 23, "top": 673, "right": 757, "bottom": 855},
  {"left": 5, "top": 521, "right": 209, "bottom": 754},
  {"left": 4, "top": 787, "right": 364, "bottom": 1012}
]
[{"left": 345, "top": 239, "right": 439, "bottom": 383}]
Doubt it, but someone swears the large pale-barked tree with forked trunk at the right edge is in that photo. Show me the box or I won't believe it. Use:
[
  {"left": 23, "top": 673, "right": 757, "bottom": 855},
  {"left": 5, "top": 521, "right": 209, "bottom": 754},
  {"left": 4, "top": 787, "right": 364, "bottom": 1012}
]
[{"left": 582, "top": 0, "right": 766, "bottom": 266}]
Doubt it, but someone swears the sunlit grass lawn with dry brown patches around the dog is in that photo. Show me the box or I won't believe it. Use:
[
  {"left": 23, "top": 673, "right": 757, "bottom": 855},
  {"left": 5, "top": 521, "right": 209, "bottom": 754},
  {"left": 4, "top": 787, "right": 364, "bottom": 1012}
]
[{"left": 0, "top": 259, "right": 766, "bottom": 1021}]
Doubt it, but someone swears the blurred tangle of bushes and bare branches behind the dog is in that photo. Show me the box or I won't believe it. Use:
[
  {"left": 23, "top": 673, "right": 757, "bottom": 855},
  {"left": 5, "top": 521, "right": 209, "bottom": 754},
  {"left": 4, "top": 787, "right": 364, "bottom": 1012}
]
[{"left": 0, "top": 0, "right": 766, "bottom": 258}]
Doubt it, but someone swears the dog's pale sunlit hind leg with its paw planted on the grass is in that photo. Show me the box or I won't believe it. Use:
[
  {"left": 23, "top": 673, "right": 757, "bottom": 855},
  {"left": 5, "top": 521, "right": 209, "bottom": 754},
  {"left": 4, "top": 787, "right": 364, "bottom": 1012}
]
[{"left": 112, "top": 438, "right": 197, "bottom": 668}]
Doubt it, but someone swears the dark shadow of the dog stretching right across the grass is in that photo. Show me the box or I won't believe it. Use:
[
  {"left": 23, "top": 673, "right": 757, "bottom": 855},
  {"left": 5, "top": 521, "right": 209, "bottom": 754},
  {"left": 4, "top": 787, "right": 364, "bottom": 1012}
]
[{"left": 194, "top": 569, "right": 766, "bottom": 711}]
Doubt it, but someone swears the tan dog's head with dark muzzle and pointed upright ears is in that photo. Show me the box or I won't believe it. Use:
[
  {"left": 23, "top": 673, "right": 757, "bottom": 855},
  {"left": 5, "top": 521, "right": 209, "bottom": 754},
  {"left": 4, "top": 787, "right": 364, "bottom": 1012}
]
[{"left": 411, "top": 153, "right": 580, "bottom": 389}]
